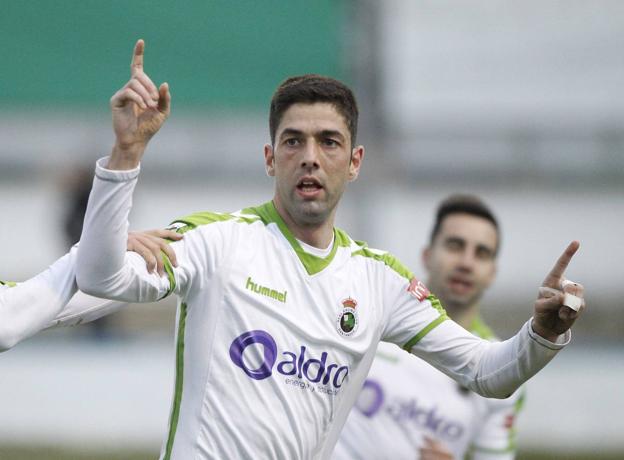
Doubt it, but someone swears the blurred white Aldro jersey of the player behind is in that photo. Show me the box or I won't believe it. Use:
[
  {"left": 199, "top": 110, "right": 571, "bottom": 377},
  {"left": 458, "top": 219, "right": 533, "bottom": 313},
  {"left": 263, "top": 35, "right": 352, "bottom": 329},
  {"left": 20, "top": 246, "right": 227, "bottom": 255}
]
[{"left": 332, "top": 319, "right": 523, "bottom": 460}]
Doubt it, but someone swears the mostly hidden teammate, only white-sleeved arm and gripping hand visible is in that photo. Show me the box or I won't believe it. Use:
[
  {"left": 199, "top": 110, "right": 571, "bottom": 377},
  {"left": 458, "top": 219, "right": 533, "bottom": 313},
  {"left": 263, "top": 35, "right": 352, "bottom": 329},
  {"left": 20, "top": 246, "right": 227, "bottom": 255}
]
[{"left": 0, "top": 230, "right": 181, "bottom": 352}]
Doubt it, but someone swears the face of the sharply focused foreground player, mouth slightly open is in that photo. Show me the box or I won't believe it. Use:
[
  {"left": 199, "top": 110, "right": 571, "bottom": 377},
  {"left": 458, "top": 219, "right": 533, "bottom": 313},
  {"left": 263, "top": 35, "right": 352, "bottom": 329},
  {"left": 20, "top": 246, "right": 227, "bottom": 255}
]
[{"left": 264, "top": 103, "right": 364, "bottom": 227}]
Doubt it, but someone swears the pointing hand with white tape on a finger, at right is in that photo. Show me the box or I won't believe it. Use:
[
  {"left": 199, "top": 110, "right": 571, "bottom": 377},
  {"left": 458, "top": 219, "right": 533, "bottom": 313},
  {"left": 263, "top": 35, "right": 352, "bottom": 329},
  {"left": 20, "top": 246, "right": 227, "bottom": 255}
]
[{"left": 533, "top": 241, "right": 585, "bottom": 342}]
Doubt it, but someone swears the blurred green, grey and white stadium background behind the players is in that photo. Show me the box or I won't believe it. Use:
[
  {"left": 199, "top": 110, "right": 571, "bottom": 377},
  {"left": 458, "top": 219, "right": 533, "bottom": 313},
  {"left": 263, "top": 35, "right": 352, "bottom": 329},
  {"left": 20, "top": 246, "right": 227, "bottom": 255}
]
[{"left": 0, "top": 0, "right": 624, "bottom": 459}]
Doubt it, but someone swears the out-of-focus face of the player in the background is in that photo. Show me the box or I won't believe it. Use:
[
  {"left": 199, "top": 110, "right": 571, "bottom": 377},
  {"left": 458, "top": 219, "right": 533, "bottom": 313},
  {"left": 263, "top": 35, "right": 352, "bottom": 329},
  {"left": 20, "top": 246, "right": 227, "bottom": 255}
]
[{"left": 423, "top": 213, "right": 498, "bottom": 310}]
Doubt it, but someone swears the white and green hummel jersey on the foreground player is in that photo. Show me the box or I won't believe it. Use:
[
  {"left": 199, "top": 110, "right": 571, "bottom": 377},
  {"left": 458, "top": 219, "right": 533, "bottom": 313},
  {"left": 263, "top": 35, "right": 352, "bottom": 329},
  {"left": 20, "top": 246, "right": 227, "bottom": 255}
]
[{"left": 77, "top": 159, "right": 569, "bottom": 460}]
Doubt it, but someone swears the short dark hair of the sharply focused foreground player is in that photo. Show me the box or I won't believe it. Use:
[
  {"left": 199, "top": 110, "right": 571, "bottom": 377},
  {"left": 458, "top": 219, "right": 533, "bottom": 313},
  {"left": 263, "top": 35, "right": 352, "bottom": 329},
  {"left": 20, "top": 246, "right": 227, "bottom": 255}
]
[{"left": 269, "top": 74, "right": 358, "bottom": 145}]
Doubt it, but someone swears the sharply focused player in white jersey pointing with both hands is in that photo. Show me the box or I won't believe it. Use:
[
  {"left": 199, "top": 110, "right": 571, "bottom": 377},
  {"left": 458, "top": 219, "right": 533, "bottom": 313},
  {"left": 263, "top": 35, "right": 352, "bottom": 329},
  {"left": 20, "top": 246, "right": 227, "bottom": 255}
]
[{"left": 76, "top": 40, "right": 582, "bottom": 460}]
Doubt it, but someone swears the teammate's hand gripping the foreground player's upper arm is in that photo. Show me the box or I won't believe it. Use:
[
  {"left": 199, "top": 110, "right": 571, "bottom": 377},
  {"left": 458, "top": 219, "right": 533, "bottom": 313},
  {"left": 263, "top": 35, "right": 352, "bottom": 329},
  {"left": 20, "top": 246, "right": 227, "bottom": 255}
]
[{"left": 128, "top": 230, "right": 183, "bottom": 276}]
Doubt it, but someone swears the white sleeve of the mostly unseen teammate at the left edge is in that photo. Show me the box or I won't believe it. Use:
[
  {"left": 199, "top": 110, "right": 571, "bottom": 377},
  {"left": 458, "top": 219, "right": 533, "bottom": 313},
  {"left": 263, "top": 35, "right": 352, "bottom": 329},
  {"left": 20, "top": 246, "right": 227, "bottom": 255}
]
[{"left": 0, "top": 247, "right": 125, "bottom": 351}]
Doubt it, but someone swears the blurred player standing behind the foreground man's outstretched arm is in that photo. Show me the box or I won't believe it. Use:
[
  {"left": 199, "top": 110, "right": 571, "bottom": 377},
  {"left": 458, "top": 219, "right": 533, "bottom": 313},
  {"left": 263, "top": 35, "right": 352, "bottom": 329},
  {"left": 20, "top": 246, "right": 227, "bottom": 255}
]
[{"left": 333, "top": 195, "right": 523, "bottom": 460}]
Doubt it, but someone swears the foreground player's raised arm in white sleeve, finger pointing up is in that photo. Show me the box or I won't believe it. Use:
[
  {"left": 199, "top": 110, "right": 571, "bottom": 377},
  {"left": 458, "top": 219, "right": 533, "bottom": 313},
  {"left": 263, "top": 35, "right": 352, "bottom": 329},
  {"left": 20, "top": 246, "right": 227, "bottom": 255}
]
[{"left": 76, "top": 40, "right": 177, "bottom": 302}]
